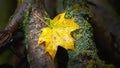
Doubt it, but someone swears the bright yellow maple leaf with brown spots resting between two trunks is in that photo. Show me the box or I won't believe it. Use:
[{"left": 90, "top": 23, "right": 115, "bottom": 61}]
[{"left": 38, "top": 13, "right": 79, "bottom": 59}]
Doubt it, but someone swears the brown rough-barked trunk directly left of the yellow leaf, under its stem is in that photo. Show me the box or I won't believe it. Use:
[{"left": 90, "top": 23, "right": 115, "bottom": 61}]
[{"left": 28, "top": 0, "right": 54, "bottom": 68}]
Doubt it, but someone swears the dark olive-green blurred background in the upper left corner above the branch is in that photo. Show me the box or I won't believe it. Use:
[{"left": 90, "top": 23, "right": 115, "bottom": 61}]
[{"left": 0, "top": 0, "right": 17, "bottom": 30}]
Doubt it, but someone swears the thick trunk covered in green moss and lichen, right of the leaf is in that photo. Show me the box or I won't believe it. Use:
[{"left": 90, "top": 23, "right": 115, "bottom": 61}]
[{"left": 63, "top": 0, "right": 114, "bottom": 68}]
